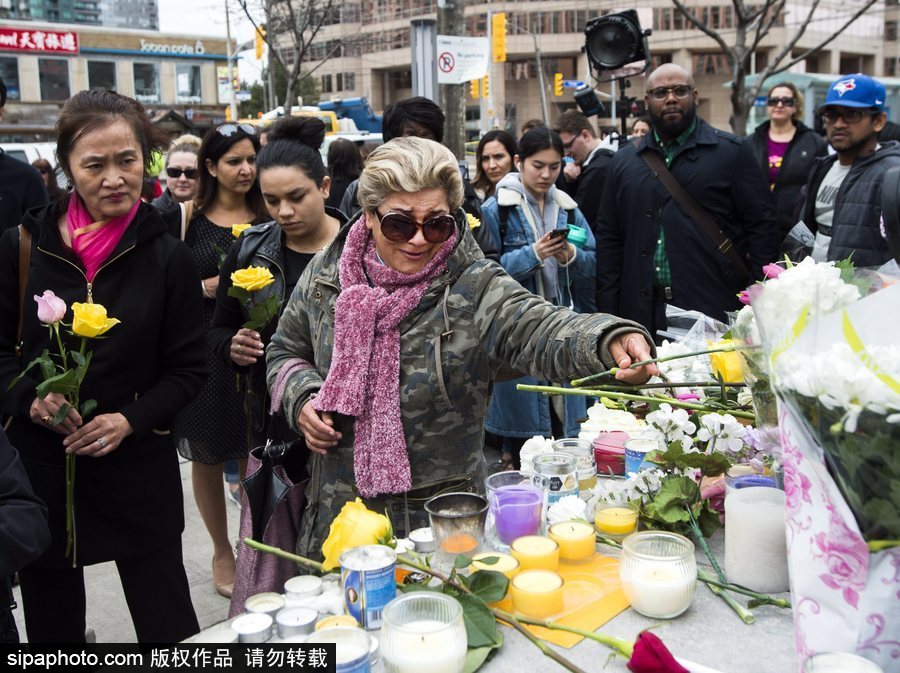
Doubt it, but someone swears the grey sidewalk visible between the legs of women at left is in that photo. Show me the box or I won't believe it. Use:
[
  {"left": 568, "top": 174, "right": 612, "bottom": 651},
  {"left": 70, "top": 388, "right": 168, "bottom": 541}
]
[{"left": 14, "top": 460, "right": 240, "bottom": 643}]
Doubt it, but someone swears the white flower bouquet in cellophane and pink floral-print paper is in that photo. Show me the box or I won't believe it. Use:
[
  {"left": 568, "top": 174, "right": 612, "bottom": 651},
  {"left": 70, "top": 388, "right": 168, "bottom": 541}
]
[{"left": 751, "top": 259, "right": 900, "bottom": 670}]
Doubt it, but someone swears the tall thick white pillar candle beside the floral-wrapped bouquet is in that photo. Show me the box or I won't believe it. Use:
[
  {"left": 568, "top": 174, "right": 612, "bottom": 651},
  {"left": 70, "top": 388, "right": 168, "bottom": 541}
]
[{"left": 725, "top": 486, "right": 790, "bottom": 593}]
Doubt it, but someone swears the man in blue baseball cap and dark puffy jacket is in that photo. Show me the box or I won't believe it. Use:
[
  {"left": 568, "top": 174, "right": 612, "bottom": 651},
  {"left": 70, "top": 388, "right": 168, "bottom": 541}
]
[{"left": 792, "top": 73, "right": 900, "bottom": 267}]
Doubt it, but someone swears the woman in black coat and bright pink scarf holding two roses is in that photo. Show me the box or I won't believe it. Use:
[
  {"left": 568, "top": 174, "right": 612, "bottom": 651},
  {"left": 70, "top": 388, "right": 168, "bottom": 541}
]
[{"left": 0, "top": 90, "right": 206, "bottom": 643}]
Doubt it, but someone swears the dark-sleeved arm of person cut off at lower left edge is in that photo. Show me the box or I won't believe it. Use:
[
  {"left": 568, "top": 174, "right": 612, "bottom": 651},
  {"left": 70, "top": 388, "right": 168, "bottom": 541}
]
[{"left": 0, "top": 429, "right": 50, "bottom": 643}]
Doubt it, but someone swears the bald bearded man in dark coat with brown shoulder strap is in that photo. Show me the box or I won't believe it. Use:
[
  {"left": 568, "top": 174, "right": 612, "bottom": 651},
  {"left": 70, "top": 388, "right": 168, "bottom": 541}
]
[{"left": 596, "top": 63, "right": 779, "bottom": 335}]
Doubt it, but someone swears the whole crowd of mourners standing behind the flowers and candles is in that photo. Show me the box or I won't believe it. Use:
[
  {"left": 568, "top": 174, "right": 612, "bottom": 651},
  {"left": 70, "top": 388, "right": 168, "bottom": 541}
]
[{"left": 0, "top": 64, "right": 900, "bottom": 643}]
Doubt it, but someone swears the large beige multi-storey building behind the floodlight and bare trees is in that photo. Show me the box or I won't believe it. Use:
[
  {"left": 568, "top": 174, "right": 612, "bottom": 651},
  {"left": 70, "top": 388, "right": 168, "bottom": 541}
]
[{"left": 296, "top": 0, "right": 884, "bottom": 132}]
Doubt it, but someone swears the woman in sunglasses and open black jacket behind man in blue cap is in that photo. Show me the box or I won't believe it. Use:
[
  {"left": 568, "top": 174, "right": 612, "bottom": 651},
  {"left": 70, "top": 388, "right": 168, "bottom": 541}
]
[{"left": 752, "top": 82, "right": 828, "bottom": 240}]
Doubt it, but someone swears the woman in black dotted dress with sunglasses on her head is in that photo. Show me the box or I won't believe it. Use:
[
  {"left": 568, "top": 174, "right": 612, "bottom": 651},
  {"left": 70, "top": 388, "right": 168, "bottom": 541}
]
[{"left": 173, "top": 124, "right": 268, "bottom": 597}]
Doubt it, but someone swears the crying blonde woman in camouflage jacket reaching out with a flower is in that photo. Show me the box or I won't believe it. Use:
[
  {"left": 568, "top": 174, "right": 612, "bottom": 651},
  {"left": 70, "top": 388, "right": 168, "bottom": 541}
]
[{"left": 266, "top": 137, "right": 650, "bottom": 557}]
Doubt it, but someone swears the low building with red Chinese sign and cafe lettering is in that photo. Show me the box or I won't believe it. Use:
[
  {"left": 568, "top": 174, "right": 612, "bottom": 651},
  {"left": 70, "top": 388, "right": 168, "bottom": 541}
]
[{"left": 0, "top": 21, "right": 232, "bottom": 142}]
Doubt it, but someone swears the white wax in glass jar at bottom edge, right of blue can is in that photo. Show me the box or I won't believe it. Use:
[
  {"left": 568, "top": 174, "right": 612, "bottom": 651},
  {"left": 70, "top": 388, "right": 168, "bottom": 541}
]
[{"left": 381, "top": 619, "right": 466, "bottom": 673}]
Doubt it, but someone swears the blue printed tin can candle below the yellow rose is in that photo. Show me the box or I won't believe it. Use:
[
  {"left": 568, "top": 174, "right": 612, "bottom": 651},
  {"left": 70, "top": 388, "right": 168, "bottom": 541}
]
[{"left": 339, "top": 544, "right": 397, "bottom": 631}]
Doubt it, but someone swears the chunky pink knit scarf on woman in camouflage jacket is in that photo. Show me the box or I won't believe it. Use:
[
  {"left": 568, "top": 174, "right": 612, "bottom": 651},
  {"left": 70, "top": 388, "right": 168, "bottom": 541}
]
[{"left": 313, "top": 217, "right": 456, "bottom": 497}]
